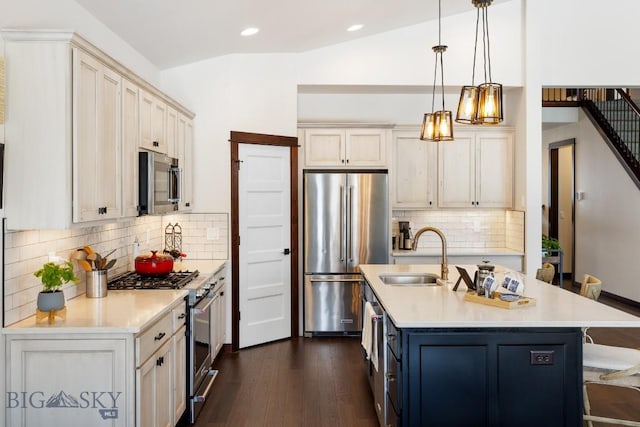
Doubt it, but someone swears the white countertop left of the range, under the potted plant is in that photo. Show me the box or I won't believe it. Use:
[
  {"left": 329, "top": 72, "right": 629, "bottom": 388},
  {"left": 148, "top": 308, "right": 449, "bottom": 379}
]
[{"left": 3, "top": 289, "right": 187, "bottom": 334}]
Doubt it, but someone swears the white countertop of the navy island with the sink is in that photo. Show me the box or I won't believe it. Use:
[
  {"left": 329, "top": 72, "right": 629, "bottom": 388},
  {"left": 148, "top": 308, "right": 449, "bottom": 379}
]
[{"left": 360, "top": 264, "right": 640, "bottom": 328}]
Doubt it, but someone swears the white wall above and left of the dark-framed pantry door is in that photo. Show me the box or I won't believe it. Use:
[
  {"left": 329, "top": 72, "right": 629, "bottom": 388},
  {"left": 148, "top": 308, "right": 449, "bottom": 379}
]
[{"left": 163, "top": 54, "right": 297, "bottom": 212}]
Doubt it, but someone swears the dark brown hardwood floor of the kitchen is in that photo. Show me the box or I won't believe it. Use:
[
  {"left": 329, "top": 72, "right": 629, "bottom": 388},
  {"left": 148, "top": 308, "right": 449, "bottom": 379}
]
[{"left": 195, "top": 284, "right": 640, "bottom": 427}]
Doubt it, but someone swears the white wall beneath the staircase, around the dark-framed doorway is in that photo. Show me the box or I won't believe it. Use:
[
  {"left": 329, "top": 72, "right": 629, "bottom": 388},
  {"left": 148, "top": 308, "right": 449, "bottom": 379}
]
[{"left": 543, "top": 112, "right": 640, "bottom": 301}]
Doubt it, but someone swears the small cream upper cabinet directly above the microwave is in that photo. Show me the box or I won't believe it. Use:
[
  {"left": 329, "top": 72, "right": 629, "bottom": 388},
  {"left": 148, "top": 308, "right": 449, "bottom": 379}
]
[{"left": 140, "top": 89, "right": 167, "bottom": 154}]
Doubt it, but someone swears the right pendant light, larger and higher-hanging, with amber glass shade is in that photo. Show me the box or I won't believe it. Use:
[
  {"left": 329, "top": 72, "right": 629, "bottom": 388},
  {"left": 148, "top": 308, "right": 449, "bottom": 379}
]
[{"left": 456, "top": 0, "right": 504, "bottom": 125}]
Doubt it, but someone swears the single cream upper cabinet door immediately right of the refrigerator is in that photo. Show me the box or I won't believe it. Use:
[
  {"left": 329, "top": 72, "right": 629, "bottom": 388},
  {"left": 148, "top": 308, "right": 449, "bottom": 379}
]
[{"left": 391, "top": 128, "right": 438, "bottom": 209}]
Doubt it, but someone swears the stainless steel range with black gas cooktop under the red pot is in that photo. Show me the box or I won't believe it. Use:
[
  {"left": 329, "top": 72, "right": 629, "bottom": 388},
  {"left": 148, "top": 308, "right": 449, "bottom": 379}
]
[{"left": 107, "top": 270, "right": 218, "bottom": 424}]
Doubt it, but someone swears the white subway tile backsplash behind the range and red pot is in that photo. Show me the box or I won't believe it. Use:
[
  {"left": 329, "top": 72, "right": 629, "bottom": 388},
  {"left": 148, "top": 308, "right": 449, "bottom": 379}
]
[{"left": 3, "top": 213, "right": 229, "bottom": 325}]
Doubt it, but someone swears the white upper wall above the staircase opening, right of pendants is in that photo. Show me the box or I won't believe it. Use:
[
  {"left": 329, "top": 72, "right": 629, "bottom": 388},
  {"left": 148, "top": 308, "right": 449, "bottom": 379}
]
[{"left": 540, "top": 0, "right": 640, "bottom": 87}]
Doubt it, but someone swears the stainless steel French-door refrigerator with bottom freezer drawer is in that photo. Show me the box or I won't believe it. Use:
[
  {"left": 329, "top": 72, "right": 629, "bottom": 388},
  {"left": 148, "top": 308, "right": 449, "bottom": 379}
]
[{"left": 303, "top": 170, "right": 389, "bottom": 335}]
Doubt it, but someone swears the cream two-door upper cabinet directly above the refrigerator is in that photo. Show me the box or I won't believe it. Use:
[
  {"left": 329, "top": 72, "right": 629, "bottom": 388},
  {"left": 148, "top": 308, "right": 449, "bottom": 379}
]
[{"left": 304, "top": 128, "right": 388, "bottom": 167}]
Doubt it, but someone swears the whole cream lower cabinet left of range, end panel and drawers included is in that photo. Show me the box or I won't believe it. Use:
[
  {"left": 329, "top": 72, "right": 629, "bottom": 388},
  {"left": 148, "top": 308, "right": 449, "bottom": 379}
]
[{"left": 4, "top": 301, "right": 187, "bottom": 427}]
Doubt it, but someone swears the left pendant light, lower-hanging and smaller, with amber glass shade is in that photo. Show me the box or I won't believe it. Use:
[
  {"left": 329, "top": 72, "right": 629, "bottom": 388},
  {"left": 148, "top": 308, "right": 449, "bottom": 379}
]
[{"left": 420, "top": 0, "right": 453, "bottom": 141}]
